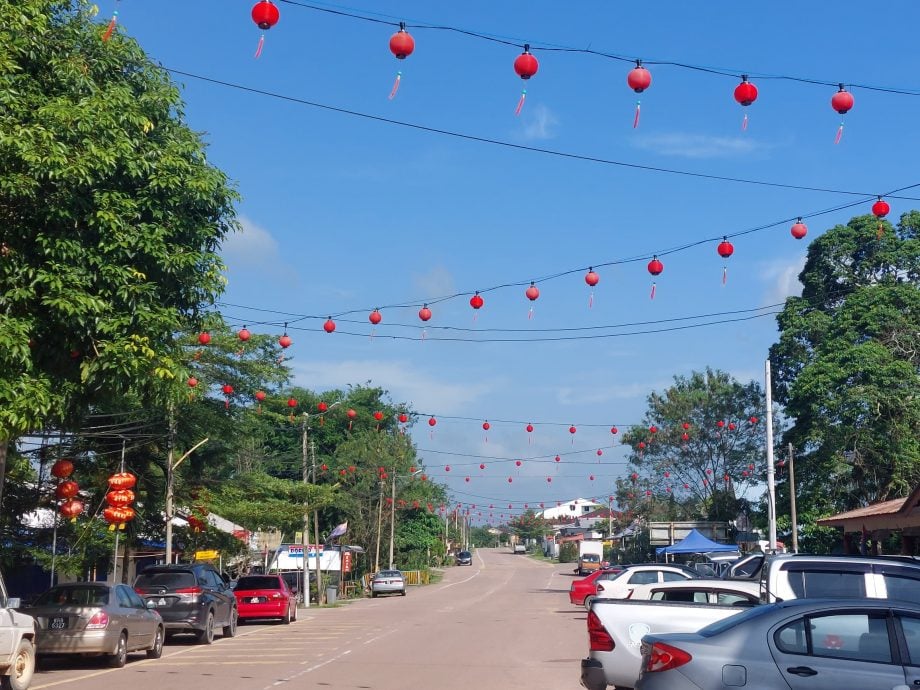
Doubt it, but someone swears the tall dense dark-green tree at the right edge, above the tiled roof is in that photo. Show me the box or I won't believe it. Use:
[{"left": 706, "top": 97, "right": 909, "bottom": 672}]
[{"left": 770, "top": 211, "right": 920, "bottom": 514}]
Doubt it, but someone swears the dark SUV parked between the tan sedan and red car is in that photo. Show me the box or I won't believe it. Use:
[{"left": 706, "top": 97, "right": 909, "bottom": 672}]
[{"left": 134, "top": 563, "right": 239, "bottom": 644}]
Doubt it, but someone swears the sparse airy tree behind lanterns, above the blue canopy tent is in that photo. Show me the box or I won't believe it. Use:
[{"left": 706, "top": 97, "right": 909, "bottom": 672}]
[{"left": 617, "top": 369, "right": 765, "bottom": 520}]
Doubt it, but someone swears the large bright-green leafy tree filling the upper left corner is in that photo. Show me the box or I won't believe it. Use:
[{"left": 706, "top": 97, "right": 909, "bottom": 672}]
[{"left": 0, "top": 0, "right": 241, "bottom": 502}]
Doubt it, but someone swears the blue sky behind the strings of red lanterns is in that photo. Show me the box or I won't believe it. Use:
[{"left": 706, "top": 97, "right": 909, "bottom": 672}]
[{"left": 122, "top": 0, "right": 920, "bottom": 514}]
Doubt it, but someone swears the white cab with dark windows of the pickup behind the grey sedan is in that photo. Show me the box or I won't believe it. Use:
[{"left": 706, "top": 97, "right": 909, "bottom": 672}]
[{"left": 760, "top": 554, "right": 920, "bottom": 604}]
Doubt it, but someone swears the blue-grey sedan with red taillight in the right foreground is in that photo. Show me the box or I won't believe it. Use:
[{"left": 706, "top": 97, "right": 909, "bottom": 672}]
[{"left": 636, "top": 599, "right": 920, "bottom": 690}]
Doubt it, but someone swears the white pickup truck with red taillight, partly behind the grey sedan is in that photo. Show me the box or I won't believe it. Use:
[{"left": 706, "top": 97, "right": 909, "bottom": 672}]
[{"left": 581, "top": 554, "right": 920, "bottom": 690}]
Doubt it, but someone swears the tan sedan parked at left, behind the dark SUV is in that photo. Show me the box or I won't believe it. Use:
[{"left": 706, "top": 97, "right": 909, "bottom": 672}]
[{"left": 24, "top": 582, "right": 165, "bottom": 668}]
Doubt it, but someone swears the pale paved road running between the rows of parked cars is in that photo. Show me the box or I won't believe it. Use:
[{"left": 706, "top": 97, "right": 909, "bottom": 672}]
[{"left": 32, "top": 549, "right": 587, "bottom": 690}]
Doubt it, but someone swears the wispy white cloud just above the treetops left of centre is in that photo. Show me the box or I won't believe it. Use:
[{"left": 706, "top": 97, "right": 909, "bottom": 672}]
[{"left": 292, "top": 360, "right": 493, "bottom": 414}]
